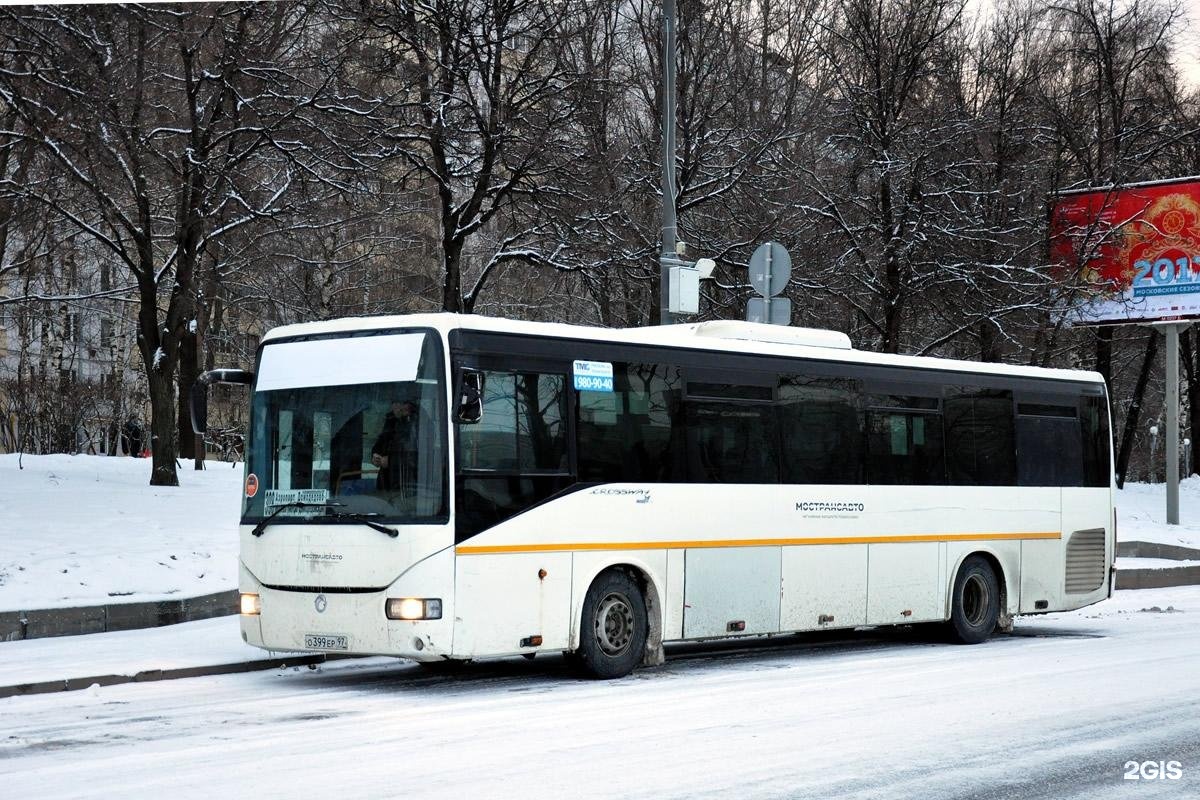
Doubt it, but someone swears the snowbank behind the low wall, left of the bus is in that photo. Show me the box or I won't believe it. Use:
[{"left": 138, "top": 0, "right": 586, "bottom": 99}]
[{"left": 0, "top": 455, "right": 242, "bottom": 610}]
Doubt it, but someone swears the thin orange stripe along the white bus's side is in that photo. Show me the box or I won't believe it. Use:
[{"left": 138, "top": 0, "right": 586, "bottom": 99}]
[{"left": 455, "top": 530, "right": 1062, "bottom": 555}]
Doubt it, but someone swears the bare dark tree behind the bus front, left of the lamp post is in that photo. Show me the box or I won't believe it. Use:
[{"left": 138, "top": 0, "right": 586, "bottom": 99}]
[{"left": 356, "top": 0, "right": 577, "bottom": 312}]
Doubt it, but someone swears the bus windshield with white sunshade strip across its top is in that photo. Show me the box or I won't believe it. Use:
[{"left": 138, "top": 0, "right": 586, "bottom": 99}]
[{"left": 242, "top": 332, "right": 448, "bottom": 524}]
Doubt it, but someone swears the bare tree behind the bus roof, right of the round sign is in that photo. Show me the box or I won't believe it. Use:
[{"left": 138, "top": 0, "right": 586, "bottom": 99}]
[{"left": 806, "top": 0, "right": 972, "bottom": 353}]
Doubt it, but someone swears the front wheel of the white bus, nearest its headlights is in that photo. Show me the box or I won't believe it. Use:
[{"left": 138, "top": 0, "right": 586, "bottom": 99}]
[{"left": 577, "top": 570, "right": 649, "bottom": 680}]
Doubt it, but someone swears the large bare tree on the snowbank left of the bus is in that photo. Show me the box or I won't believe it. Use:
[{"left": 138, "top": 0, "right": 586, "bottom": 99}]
[{"left": 0, "top": 4, "right": 364, "bottom": 485}]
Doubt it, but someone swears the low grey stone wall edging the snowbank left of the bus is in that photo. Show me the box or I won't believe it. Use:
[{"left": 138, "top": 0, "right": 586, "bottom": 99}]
[{"left": 0, "top": 589, "right": 238, "bottom": 642}]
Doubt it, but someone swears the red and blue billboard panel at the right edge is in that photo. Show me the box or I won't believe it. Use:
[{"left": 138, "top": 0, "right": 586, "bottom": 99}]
[{"left": 1050, "top": 178, "right": 1200, "bottom": 325}]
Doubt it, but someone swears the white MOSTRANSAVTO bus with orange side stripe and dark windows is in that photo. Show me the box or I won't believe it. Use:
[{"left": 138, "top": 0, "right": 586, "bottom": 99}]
[{"left": 193, "top": 314, "right": 1116, "bottom": 678}]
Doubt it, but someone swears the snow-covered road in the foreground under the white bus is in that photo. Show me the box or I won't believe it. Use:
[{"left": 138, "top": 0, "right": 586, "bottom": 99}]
[{"left": 0, "top": 588, "right": 1200, "bottom": 800}]
